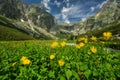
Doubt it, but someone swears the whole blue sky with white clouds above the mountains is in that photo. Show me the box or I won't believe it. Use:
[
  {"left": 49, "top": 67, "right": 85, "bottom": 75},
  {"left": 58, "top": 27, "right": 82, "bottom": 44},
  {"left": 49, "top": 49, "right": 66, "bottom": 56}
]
[{"left": 21, "top": 0, "right": 107, "bottom": 23}]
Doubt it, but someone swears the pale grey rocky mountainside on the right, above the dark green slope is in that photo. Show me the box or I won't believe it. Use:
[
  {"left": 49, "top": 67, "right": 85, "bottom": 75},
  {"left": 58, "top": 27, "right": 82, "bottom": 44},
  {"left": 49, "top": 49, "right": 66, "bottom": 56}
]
[{"left": 74, "top": 0, "right": 120, "bottom": 35}]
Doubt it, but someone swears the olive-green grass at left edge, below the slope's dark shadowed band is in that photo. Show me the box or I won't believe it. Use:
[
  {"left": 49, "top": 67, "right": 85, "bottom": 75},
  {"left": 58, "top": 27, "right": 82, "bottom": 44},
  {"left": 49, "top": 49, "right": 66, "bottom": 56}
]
[{"left": 0, "top": 25, "right": 34, "bottom": 40}]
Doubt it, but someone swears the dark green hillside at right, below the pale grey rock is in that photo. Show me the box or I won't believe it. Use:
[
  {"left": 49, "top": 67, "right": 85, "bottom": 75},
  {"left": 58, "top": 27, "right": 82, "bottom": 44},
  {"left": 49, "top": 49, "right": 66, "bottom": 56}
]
[{"left": 79, "top": 21, "right": 120, "bottom": 41}]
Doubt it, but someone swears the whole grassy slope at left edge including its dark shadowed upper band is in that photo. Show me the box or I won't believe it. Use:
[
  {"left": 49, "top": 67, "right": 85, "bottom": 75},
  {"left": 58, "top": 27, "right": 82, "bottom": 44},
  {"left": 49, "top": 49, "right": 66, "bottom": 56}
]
[{"left": 0, "top": 16, "right": 34, "bottom": 40}]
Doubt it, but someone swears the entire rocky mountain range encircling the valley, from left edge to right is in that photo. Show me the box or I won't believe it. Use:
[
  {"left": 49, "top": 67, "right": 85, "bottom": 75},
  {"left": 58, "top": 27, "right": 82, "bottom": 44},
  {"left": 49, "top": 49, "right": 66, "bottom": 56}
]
[{"left": 0, "top": 0, "right": 120, "bottom": 40}]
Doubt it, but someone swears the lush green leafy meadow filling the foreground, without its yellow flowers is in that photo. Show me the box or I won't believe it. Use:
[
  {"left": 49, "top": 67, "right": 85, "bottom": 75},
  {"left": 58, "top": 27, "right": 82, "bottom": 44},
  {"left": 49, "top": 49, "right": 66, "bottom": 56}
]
[{"left": 0, "top": 40, "right": 120, "bottom": 80}]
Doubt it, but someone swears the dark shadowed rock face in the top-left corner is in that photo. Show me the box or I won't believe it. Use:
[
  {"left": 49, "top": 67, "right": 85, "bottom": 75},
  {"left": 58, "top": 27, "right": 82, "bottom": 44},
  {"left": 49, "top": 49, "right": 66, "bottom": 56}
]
[{"left": 0, "top": 0, "right": 21, "bottom": 19}]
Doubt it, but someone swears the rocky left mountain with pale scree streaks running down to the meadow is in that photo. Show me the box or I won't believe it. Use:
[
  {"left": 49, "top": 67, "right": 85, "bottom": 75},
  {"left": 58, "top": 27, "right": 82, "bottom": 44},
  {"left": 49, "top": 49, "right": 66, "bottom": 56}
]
[{"left": 0, "top": 0, "right": 57, "bottom": 39}]
